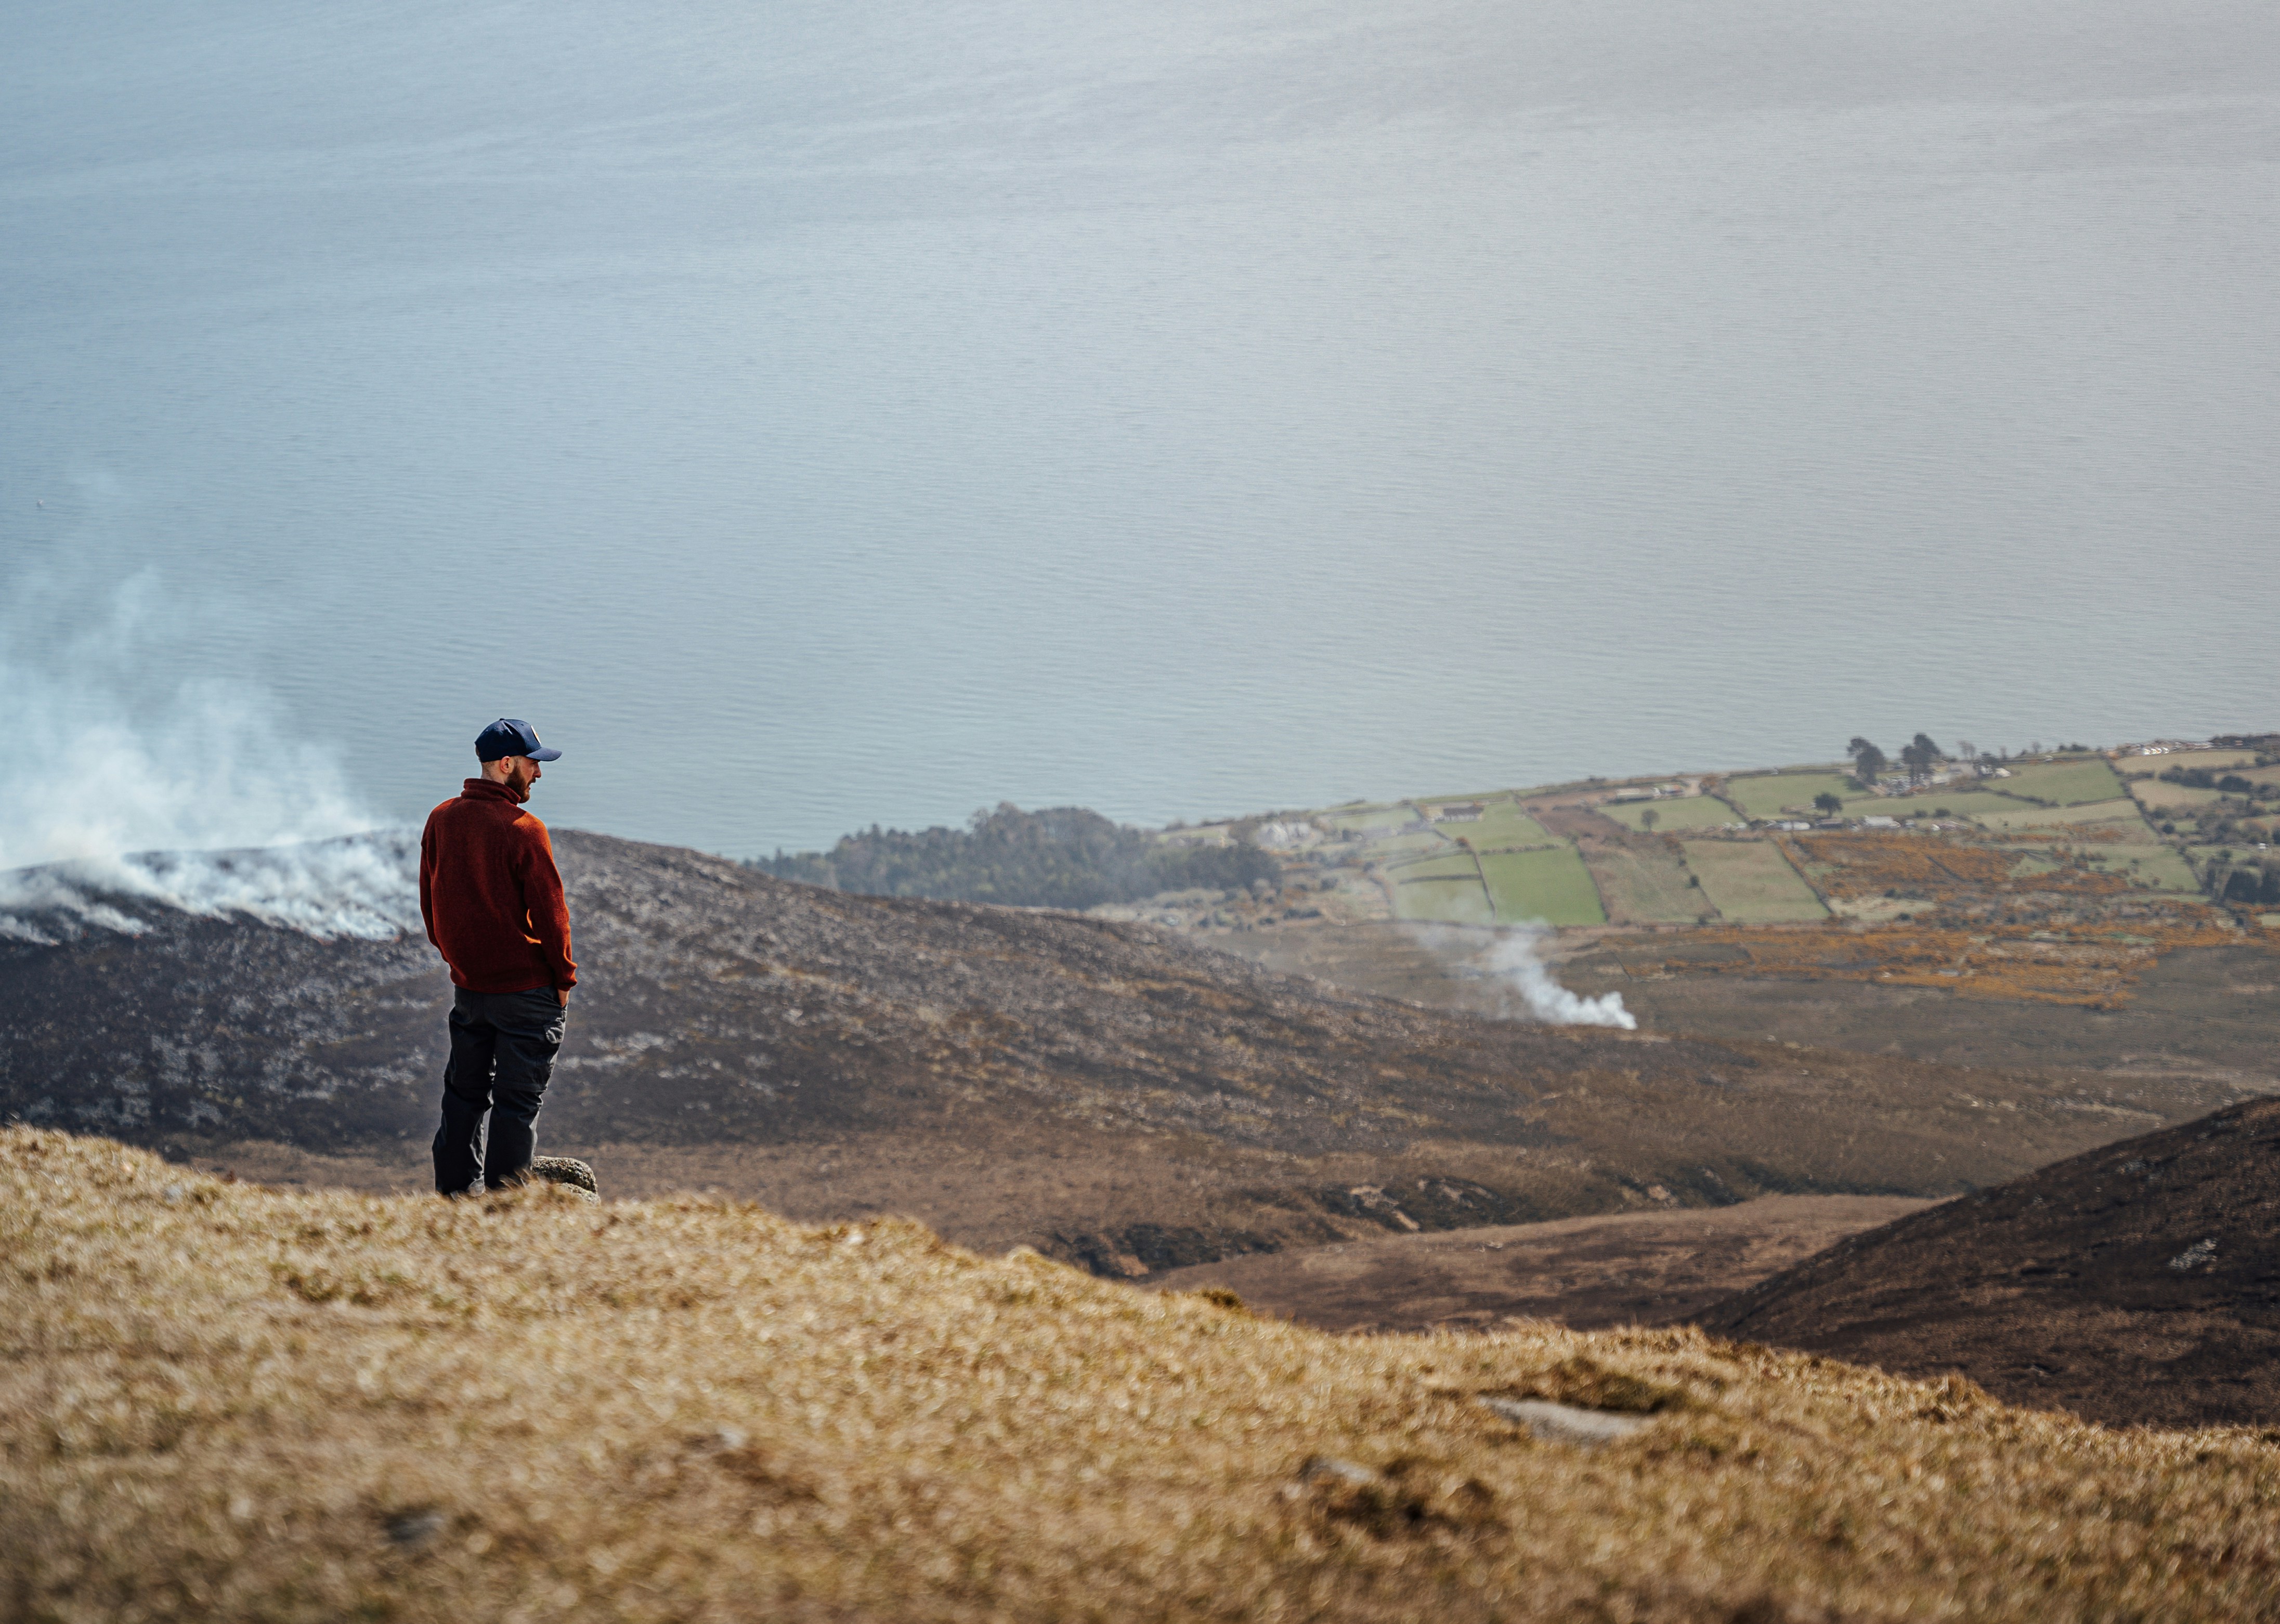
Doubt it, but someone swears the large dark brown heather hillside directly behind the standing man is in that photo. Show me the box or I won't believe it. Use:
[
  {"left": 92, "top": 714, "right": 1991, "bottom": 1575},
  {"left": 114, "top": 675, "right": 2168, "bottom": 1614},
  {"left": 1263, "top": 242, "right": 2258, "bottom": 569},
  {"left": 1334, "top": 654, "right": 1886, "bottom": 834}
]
[{"left": 0, "top": 833, "right": 2207, "bottom": 1275}]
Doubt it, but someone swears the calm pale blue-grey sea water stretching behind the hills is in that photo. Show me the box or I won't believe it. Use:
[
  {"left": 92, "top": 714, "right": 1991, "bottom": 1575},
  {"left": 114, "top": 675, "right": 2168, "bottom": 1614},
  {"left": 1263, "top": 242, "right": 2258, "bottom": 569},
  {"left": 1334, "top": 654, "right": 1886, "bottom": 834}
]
[{"left": 0, "top": 0, "right": 2280, "bottom": 860}]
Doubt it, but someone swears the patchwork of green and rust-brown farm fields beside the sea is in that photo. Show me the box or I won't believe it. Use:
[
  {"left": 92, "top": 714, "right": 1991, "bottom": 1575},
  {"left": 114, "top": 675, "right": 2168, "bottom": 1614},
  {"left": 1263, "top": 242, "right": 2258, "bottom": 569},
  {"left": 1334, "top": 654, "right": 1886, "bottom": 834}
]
[{"left": 1108, "top": 734, "right": 2280, "bottom": 1008}]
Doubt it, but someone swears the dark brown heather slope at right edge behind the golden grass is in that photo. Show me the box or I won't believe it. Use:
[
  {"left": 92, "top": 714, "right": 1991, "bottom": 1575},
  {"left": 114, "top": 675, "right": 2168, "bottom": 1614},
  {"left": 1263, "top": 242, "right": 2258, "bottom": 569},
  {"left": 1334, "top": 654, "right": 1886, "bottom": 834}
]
[{"left": 1696, "top": 1099, "right": 2280, "bottom": 1425}]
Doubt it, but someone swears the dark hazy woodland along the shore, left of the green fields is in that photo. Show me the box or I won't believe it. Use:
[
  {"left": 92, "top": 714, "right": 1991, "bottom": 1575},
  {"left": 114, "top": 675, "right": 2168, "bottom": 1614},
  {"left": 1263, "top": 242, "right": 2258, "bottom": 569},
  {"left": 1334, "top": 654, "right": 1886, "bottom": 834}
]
[{"left": 746, "top": 803, "right": 1281, "bottom": 908}]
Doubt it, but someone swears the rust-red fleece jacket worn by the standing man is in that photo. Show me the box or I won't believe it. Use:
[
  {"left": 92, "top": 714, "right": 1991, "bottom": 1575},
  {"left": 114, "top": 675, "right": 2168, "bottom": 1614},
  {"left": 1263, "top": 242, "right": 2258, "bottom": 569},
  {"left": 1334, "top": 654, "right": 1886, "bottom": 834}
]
[{"left": 420, "top": 778, "right": 577, "bottom": 992}]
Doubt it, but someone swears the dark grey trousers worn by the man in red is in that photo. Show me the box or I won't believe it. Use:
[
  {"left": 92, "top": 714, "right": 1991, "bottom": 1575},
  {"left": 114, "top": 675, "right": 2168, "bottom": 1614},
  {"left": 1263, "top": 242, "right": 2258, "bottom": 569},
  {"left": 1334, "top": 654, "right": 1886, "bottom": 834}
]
[{"left": 436, "top": 988, "right": 568, "bottom": 1195}]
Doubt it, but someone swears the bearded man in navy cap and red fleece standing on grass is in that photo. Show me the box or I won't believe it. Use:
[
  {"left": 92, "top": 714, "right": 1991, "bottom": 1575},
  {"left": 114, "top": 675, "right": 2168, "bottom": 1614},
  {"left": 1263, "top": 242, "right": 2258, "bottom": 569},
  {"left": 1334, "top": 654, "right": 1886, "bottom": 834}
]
[{"left": 420, "top": 716, "right": 577, "bottom": 1195}]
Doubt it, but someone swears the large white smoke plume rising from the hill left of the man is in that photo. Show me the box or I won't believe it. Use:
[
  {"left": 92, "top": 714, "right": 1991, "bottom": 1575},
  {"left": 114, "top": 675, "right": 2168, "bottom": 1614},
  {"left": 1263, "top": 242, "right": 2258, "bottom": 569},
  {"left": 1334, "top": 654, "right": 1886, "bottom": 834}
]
[{"left": 0, "top": 558, "right": 420, "bottom": 942}]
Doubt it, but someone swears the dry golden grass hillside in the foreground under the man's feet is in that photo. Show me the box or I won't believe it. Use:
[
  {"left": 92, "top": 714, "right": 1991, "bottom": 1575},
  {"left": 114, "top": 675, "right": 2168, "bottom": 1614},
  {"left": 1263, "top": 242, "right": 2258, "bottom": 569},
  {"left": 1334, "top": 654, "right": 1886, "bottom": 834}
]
[{"left": 0, "top": 1129, "right": 2280, "bottom": 1624}]
